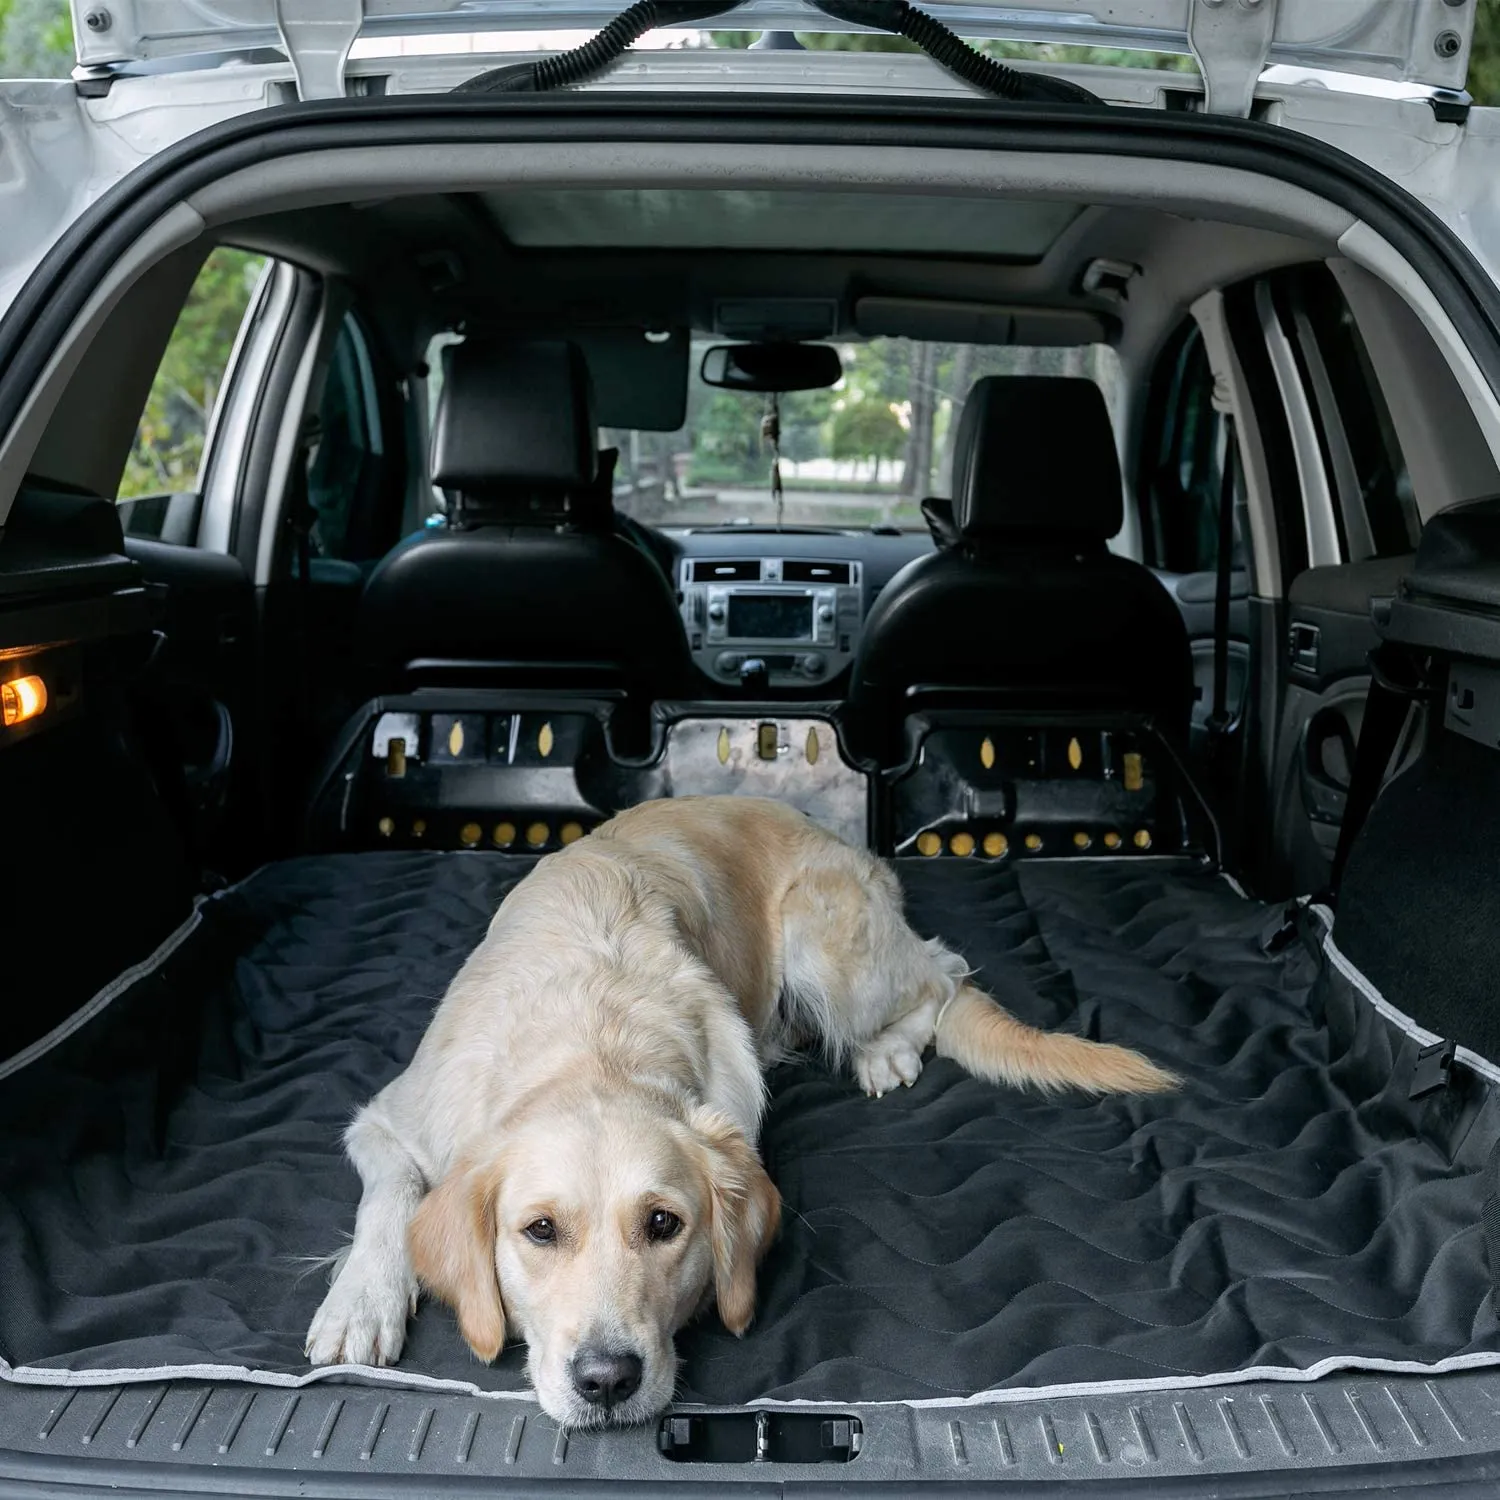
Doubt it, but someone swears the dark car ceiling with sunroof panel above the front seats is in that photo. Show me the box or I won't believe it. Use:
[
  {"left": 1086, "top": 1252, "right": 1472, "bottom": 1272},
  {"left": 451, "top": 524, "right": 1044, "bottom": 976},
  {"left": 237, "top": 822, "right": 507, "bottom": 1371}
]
[{"left": 219, "top": 188, "right": 1320, "bottom": 375}]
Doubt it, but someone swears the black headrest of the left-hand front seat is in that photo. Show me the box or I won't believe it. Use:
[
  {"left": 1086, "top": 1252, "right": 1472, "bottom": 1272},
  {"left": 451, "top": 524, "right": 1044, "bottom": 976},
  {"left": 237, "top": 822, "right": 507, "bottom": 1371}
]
[{"left": 432, "top": 339, "right": 599, "bottom": 522}]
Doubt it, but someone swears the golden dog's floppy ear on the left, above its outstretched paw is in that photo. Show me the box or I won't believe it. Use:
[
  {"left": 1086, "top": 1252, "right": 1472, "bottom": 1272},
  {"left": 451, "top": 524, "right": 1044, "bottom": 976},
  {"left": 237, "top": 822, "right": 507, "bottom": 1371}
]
[{"left": 407, "top": 1163, "right": 506, "bottom": 1364}]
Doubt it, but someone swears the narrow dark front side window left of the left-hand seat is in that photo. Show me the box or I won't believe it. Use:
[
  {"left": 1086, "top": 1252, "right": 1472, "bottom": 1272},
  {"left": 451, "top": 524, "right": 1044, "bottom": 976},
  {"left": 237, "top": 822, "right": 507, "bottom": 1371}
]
[{"left": 308, "top": 314, "right": 390, "bottom": 563}]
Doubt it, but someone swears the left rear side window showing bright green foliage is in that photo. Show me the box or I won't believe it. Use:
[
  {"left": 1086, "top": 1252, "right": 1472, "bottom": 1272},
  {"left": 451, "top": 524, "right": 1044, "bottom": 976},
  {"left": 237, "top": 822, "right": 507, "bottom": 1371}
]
[{"left": 117, "top": 246, "right": 267, "bottom": 543}]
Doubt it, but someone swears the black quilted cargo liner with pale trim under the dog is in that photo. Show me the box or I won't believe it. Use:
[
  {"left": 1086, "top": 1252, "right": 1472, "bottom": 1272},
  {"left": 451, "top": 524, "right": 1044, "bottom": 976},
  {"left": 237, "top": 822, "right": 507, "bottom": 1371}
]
[{"left": 0, "top": 854, "right": 1500, "bottom": 1404}]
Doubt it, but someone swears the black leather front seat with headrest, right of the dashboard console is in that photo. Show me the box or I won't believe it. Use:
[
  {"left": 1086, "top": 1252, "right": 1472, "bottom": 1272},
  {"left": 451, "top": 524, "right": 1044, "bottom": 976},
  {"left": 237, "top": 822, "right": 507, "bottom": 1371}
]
[{"left": 849, "top": 375, "right": 1193, "bottom": 765}]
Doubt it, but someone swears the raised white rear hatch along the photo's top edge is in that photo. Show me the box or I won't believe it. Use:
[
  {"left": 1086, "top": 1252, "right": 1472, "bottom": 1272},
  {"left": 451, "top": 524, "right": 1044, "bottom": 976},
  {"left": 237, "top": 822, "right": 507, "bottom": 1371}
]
[{"left": 72, "top": 0, "right": 1473, "bottom": 114}]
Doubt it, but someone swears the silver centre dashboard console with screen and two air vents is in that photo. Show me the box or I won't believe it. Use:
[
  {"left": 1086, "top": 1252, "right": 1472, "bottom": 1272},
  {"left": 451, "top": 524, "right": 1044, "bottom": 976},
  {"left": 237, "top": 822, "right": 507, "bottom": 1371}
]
[{"left": 678, "top": 557, "right": 864, "bottom": 689}]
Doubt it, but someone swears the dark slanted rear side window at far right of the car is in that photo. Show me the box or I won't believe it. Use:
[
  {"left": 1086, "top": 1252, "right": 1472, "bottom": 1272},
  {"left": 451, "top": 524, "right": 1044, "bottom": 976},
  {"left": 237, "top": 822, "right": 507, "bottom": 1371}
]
[{"left": 1275, "top": 266, "right": 1422, "bottom": 563}]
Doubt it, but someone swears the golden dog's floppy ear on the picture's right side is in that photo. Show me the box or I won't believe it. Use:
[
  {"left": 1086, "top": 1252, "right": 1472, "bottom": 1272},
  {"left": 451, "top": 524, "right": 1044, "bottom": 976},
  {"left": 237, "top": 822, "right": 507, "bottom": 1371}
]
[{"left": 689, "top": 1109, "right": 782, "bottom": 1334}]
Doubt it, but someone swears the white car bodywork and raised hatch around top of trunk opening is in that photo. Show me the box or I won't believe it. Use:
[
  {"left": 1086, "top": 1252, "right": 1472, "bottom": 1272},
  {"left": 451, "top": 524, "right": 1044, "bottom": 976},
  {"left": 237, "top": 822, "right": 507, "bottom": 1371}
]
[{"left": 0, "top": 0, "right": 1500, "bottom": 312}]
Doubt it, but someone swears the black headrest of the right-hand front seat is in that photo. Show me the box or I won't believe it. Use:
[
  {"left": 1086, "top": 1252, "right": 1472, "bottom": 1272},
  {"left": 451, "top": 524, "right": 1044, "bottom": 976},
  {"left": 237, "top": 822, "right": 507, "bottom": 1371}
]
[{"left": 953, "top": 375, "right": 1125, "bottom": 543}]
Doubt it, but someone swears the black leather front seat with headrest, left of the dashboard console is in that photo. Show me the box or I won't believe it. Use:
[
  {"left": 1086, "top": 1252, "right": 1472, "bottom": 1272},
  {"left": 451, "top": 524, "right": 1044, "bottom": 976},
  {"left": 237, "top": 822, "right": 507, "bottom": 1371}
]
[{"left": 362, "top": 341, "right": 692, "bottom": 726}]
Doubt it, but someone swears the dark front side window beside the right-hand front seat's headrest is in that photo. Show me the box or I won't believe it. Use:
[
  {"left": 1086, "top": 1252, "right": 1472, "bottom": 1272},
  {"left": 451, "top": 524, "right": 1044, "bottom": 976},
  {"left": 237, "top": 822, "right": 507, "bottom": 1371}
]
[{"left": 1137, "top": 321, "right": 1244, "bottom": 573}]
